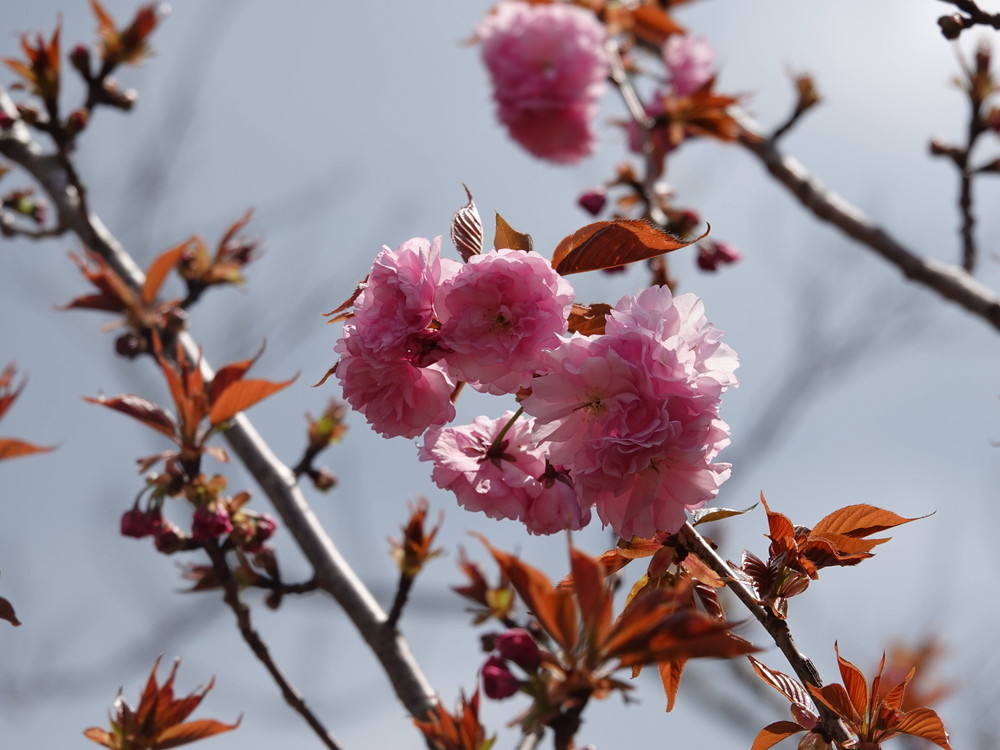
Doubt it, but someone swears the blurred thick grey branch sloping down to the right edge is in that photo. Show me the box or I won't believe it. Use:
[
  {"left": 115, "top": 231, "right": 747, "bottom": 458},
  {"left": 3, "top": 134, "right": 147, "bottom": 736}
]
[{"left": 731, "top": 108, "right": 1000, "bottom": 330}]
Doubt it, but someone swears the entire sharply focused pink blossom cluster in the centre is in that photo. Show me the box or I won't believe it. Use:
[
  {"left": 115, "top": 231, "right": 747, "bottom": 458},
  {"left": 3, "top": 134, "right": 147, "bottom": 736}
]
[{"left": 335, "top": 238, "right": 737, "bottom": 538}]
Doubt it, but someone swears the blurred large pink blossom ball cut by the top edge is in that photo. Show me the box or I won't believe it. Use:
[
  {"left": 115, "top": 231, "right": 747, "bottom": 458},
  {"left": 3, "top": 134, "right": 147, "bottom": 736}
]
[{"left": 476, "top": 0, "right": 609, "bottom": 163}]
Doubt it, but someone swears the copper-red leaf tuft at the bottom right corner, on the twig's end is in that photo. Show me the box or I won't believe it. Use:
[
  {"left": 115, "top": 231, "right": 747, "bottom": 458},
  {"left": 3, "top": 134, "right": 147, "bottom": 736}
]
[{"left": 750, "top": 649, "right": 951, "bottom": 750}]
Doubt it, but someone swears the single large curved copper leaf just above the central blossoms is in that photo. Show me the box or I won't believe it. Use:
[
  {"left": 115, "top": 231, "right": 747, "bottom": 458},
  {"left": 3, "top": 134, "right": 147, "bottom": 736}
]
[{"left": 552, "top": 219, "right": 707, "bottom": 276}]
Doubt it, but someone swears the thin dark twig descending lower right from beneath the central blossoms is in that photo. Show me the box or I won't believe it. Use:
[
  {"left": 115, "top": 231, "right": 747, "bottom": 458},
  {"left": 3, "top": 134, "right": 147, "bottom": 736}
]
[{"left": 677, "top": 523, "right": 853, "bottom": 745}]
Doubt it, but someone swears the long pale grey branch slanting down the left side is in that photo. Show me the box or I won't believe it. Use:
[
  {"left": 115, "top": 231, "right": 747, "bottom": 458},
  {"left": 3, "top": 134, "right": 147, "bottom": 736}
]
[{"left": 0, "top": 88, "right": 437, "bottom": 719}]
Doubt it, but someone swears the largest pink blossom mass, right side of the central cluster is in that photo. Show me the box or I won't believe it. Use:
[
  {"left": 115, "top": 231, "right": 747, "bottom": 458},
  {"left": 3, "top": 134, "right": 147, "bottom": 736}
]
[{"left": 523, "top": 287, "right": 737, "bottom": 538}]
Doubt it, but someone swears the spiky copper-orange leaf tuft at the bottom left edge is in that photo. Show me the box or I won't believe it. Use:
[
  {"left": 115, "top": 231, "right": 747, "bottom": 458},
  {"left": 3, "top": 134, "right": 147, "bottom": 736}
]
[{"left": 83, "top": 658, "right": 241, "bottom": 750}]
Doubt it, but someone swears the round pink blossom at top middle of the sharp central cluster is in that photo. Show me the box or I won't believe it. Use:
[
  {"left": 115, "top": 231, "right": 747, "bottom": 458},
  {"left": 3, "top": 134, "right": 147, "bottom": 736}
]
[{"left": 438, "top": 249, "right": 573, "bottom": 394}]
